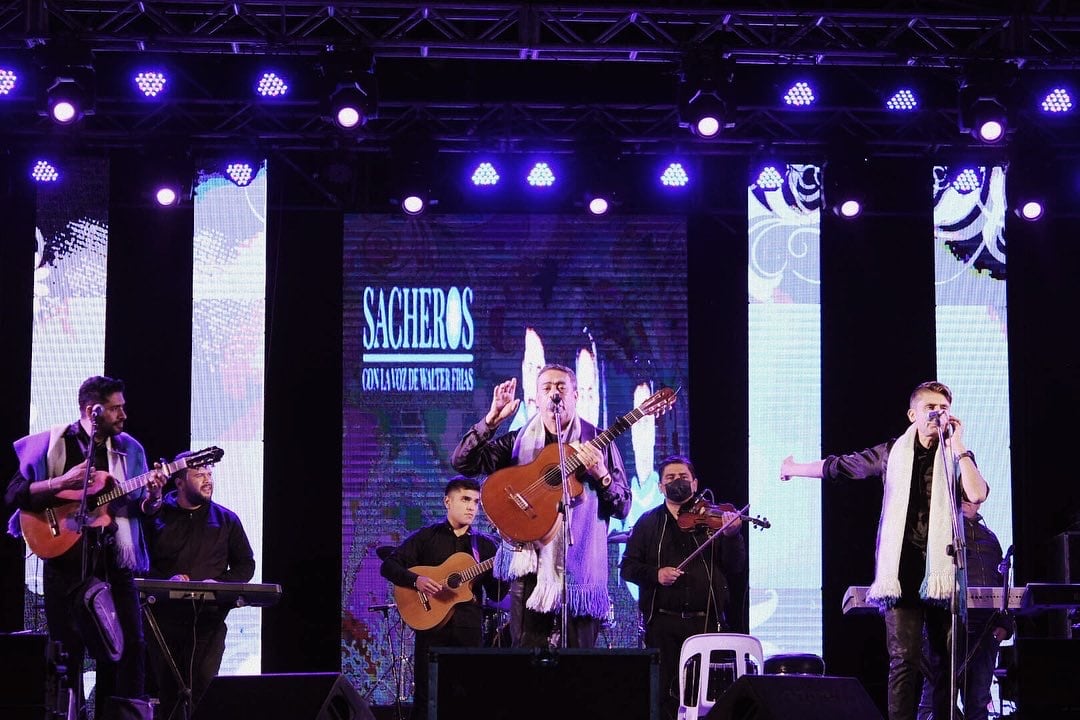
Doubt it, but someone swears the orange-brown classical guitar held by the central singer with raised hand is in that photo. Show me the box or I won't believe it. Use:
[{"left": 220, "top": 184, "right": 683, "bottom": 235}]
[{"left": 481, "top": 388, "right": 678, "bottom": 544}]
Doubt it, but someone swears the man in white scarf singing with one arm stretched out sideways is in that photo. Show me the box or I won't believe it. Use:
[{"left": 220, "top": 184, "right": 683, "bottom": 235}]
[{"left": 780, "top": 381, "right": 989, "bottom": 720}]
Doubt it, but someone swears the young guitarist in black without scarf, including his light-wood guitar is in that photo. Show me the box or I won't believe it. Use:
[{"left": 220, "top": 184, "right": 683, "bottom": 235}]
[{"left": 379, "top": 476, "right": 507, "bottom": 720}]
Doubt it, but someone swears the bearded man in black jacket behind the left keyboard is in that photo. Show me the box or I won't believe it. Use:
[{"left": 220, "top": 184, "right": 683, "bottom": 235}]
[{"left": 147, "top": 452, "right": 255, "bottom": 720}]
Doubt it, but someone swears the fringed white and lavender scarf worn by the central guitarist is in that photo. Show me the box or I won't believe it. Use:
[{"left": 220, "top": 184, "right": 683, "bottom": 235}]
[{"left": 495, "top": 413, "right": 610, "bottom": 619}]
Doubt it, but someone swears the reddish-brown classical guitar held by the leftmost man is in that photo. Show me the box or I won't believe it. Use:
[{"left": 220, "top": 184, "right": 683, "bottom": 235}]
[{"left": 18, "top": 447, "right": 225, "bottom": 559}]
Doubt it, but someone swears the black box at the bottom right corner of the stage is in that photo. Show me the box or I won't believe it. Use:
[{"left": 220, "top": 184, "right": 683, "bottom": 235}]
[{"left": 1014, "top": 638, "right": 1080, "bottom": 720}]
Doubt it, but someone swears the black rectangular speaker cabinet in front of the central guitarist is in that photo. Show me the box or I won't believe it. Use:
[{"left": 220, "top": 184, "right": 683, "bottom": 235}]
[{"left": 428, "top": 648, "right": 660, "bottom": 720}]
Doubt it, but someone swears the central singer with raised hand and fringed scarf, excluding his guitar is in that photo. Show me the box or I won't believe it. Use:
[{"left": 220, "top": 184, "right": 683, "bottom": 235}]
[{"left": 450, "top": 364, "right": 631, "bottom": 648}]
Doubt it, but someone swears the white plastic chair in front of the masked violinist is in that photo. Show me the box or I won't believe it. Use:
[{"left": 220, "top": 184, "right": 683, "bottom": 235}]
[{"left": 678, "top": 633, "right": 765, "bottom": 720}]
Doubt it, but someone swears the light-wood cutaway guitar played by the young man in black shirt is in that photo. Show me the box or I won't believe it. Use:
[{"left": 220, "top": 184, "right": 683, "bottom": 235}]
[{"left": 394, "top": 553, "right": 495, "bottom": 630}]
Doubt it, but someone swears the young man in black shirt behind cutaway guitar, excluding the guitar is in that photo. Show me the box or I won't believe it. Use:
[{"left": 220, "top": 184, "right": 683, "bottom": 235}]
[{"left": 380, "top": 476, "right": 505, "bottom": 720}]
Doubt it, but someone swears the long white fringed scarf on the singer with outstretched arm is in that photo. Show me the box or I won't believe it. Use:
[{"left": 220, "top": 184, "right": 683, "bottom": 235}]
[{"left": 866, "top": 423, "right": 956, "bottom": 608}]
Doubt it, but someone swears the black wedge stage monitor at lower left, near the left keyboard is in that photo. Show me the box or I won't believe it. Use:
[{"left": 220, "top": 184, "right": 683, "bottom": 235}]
[{"left": 191, "top": 673, "right": 375, "bottom": 720}]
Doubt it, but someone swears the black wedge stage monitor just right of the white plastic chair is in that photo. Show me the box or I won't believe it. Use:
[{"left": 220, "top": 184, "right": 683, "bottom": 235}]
[{"left": 705, "top": 675, "right": 881, "bottom": 720}]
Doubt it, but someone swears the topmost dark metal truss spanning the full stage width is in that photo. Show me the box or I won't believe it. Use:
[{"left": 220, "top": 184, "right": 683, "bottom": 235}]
[{"left": 6, "top": 0, "right": 1080, "bottom": 69}]
